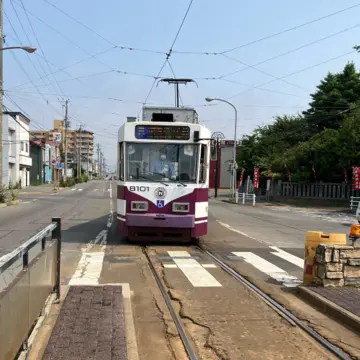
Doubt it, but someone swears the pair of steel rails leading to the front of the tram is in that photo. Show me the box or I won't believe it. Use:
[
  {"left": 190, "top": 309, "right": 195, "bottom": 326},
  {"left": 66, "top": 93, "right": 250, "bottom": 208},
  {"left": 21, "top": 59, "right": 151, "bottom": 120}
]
[{"left": 143, "top": 246, "right": 351, "bottom": 360}]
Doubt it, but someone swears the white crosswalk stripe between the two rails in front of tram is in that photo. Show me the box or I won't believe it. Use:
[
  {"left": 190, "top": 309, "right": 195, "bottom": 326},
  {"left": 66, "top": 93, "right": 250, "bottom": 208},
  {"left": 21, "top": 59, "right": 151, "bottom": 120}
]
[{"left": 168, "top": 251, "right": 222, "bottom": 287}]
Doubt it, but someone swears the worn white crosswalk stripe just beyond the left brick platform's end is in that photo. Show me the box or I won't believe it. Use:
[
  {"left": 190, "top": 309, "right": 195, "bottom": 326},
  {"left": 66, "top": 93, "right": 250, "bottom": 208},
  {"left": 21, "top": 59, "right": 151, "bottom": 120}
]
[{"left": 69, "top": 251, "right": 105, "bottom": 285}]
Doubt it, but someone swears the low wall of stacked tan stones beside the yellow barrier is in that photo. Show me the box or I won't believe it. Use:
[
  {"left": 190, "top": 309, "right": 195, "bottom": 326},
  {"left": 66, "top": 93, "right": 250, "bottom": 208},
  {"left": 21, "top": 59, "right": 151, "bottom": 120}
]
[{"left": 313, "top": 244, "right": 360, "bottom": 287}]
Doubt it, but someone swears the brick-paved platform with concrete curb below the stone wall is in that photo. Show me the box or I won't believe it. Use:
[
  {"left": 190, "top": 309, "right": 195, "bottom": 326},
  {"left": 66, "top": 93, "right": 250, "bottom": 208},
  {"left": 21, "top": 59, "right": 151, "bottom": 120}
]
[{"left": 298, "top": 286, "right": 360, "bottom": 333}]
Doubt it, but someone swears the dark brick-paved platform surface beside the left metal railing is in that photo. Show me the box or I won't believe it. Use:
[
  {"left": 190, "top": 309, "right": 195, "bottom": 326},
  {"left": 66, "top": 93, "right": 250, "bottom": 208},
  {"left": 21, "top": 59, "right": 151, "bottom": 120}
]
[{"left": 42, "top": 285, "right": 127, "bottom": 360}]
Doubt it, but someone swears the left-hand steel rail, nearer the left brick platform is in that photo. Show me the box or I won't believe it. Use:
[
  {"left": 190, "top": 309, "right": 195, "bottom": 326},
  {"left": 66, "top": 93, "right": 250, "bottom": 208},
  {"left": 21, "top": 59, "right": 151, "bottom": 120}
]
[{"left": 143, "top": 246, "right": 198, "bottom": 360}]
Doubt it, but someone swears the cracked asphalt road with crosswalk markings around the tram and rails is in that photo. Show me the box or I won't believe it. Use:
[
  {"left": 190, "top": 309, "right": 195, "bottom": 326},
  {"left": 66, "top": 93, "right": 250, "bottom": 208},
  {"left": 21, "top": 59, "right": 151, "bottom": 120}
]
[{"left": 0, "top": 182, "right": 360, "bottom": 360}]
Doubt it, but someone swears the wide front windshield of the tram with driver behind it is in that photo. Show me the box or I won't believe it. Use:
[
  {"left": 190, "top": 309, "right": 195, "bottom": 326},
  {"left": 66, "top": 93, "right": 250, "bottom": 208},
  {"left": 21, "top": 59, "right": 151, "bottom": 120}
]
[{"left": 126, "top": 143, "right": 199, "bottom": 183}]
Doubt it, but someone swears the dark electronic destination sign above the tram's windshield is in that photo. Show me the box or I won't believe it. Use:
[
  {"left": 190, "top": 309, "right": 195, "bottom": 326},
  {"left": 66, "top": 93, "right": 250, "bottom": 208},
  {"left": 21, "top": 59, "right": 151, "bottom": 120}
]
[{"left": 135, "top": 125, "right": 190, "bottom": 140}]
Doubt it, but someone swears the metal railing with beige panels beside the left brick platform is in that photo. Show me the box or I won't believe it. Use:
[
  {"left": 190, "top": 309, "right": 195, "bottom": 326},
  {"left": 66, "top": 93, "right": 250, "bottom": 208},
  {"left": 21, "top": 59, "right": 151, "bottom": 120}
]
[{"left": 0, "top": 218, "right": 61, "bottom": 360}]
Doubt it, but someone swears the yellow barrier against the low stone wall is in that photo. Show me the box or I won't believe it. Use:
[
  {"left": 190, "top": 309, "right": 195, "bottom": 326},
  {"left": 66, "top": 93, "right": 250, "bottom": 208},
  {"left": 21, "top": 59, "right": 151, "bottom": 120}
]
[{"left": 303, "top": 231, "right": 346, "bottom": 285}]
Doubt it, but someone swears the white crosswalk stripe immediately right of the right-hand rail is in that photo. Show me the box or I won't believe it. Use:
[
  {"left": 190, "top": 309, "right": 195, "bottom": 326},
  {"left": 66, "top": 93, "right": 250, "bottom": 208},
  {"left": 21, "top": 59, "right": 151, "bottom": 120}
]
[{"left": 233, "top": 252, "right": 301, "bottom": 287}]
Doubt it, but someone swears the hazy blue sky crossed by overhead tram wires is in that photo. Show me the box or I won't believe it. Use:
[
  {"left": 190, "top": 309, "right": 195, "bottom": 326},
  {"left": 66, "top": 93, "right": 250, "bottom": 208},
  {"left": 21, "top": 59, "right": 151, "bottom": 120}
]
[{"left": 4, "top": 0, "right": 360, "bottom": 167}]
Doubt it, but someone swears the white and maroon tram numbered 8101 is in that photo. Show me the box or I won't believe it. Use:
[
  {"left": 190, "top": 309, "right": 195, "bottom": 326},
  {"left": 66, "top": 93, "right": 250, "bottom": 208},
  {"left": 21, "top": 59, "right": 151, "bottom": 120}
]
[{"left": 117, "top": 106, "right": 211, "bottom": 243}]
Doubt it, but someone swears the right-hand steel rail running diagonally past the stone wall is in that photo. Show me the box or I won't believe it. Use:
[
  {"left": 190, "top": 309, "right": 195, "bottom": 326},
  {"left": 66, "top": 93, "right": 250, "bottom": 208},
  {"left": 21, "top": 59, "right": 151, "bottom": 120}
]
[{"left": 199, "top": 246, "right": 351, "bottom": 360}]
